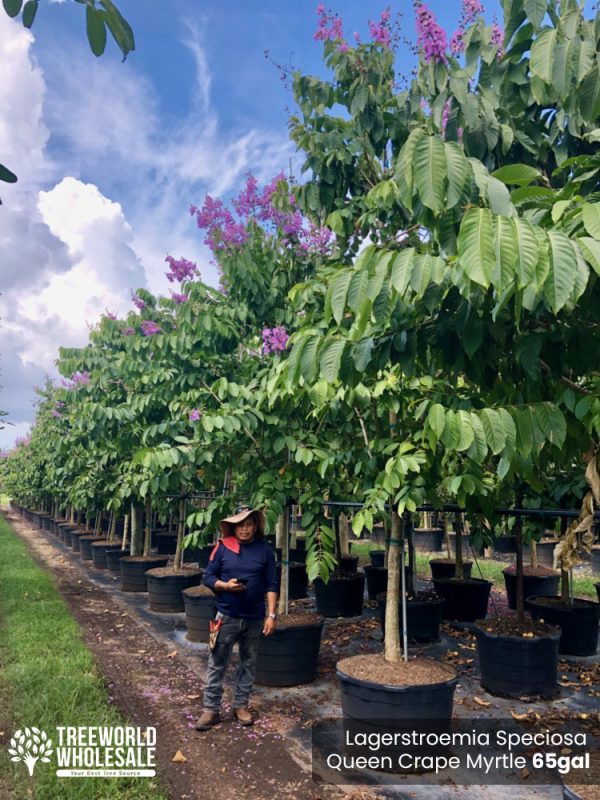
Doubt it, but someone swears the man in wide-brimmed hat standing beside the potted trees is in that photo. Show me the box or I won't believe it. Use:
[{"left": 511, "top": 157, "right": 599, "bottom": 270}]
[{"left": 196, "top": 508, "right": 278, "bottom": 731}]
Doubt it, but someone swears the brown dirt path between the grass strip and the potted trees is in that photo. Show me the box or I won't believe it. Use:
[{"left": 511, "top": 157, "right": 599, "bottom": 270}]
[{"left": 0, "top": 512, "right": 377, "bottom": 800}]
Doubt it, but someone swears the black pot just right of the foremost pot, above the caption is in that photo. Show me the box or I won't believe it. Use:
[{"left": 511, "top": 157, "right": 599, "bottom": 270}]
[{"left": 475, "top": 628, "right": 560, "bottom": 697}]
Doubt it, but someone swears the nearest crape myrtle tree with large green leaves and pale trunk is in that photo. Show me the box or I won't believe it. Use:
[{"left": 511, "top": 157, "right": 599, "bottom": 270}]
[{"left": 287, "top": 2, "right": 600, "bottom": 660}]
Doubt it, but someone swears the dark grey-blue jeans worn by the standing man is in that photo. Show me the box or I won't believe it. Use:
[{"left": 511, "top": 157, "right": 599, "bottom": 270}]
[{"left": 204, "top": 616, "right": 263, "bottom": 711}]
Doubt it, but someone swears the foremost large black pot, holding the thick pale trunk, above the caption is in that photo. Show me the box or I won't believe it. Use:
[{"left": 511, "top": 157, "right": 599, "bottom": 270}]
[{"left": 336, "top": 662, "right": 458, "bottom": 730}]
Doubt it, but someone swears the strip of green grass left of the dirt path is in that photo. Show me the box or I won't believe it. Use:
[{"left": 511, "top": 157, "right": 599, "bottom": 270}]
[{"left": 0, "top": 516, "right": 166, "bottom": 800}]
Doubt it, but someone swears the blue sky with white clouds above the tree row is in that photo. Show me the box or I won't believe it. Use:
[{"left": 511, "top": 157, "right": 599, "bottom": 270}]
[{"left": 0, "top": 0, "right": 495, "bottom": 448}]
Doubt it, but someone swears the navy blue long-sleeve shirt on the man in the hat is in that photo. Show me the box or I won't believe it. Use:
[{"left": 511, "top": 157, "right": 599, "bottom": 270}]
[{"left": 204, "top": 539, "right": 279, "bottom": 619}]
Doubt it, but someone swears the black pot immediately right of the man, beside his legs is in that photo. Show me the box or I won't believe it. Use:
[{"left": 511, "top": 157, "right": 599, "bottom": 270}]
[{"left": 256, "top": 619, "right": 324, "bottom": 686}]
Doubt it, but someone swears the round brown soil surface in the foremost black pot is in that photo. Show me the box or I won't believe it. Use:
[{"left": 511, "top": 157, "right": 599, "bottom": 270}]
[{"left": 338, "top": 653, "right": 456, "bottom": 686}]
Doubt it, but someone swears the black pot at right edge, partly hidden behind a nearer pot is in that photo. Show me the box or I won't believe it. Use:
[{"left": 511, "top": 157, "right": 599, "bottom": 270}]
[{"left": 527, "top": 597, "right": 600, "bottom": 656}]
